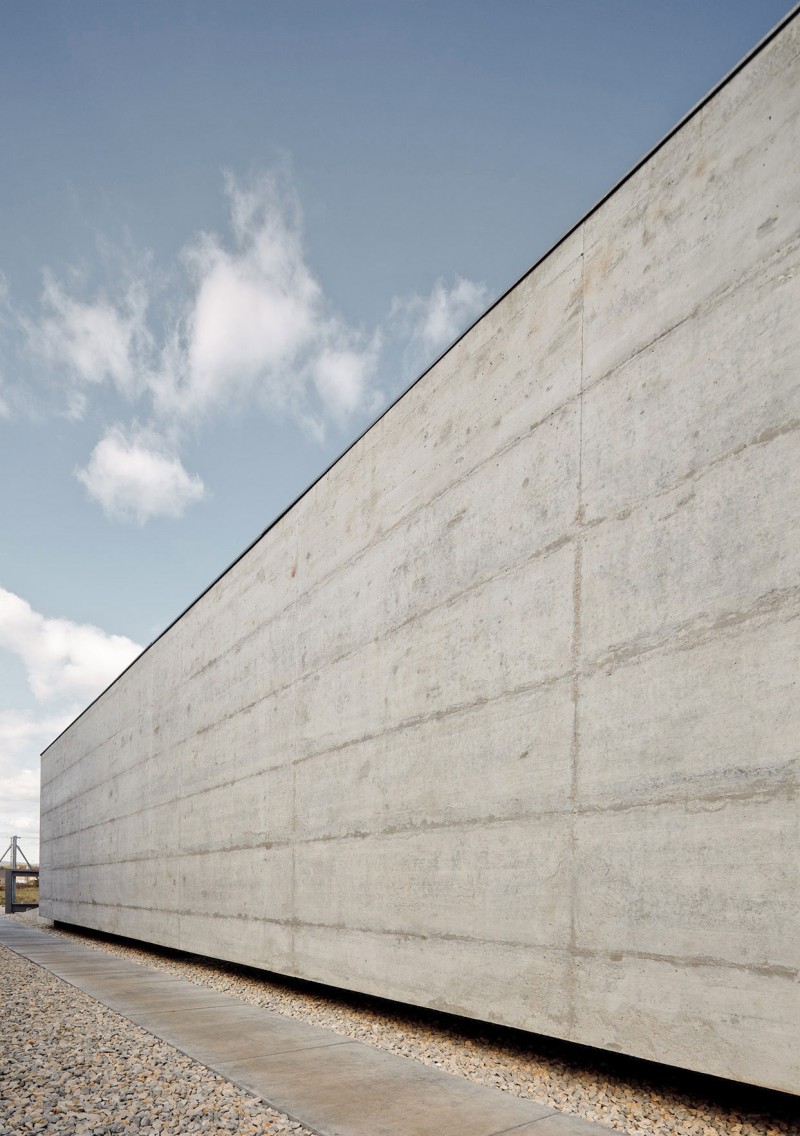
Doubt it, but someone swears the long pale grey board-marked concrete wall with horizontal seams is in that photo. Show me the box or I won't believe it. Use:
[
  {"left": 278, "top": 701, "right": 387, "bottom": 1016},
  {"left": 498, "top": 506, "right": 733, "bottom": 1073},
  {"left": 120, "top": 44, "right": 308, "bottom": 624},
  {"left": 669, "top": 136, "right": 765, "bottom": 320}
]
[{"left": 42, "top": 6, "right": 800, "bottom": 1092}]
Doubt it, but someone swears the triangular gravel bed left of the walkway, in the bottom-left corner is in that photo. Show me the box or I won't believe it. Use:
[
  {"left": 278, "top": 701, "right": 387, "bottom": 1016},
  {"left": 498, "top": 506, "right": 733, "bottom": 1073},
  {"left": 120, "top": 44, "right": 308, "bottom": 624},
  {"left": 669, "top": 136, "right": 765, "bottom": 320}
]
[{"left": 0, "top": 946, "right": 313, "bottom": 1136}]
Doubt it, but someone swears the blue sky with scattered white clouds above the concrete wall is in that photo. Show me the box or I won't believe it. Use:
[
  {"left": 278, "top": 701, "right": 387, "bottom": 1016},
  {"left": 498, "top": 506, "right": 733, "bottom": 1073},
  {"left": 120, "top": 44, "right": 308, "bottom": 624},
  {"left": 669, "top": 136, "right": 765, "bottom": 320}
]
[{"left": 0, "top": 0, "right": 791, "bottom": 855}]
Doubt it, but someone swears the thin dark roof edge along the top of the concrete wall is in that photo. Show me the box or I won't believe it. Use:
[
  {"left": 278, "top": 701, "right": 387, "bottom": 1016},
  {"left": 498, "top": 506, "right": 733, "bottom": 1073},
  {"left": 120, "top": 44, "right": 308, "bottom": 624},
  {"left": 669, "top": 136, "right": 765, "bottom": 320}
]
[{"left": 41, "top": 0, "right": 800, "bottom": 757}]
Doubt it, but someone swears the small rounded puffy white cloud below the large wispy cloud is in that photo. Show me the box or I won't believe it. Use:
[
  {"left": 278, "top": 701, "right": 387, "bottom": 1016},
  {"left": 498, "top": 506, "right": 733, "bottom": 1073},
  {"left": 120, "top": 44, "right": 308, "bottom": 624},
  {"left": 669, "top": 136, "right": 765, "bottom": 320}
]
[{"left": 75, "top": 427, "right": 206, "bottom": 525}]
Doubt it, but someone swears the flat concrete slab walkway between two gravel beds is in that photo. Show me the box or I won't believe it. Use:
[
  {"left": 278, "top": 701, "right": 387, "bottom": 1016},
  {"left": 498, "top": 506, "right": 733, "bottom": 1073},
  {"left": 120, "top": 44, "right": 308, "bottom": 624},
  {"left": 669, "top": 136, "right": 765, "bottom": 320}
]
[{"left": 0, "top": 919, "right": 610, "bottom": 1136}]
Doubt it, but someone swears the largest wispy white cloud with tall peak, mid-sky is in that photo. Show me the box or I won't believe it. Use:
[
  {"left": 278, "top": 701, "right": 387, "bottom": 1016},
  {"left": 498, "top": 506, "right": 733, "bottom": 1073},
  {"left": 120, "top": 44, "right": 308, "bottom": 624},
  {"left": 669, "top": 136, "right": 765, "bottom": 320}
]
[{"left": 151, "top": 177, "right": 376, "bottom": 432}]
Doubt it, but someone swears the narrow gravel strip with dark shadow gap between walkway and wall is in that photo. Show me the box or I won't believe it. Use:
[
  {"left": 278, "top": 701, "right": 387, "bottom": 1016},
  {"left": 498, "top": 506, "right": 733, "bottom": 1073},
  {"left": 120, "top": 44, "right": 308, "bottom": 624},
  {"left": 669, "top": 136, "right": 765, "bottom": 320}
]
[{"left": 3, "top": 911, "right": 800, "bottom": 1136}]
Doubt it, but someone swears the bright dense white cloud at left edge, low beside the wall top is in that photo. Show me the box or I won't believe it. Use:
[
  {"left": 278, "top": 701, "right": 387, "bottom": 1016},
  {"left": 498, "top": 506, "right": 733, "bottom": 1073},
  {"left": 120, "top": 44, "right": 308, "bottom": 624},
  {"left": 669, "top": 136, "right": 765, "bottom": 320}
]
[{"left": 0, "top": 587, "right": 141, "bottom": 699}]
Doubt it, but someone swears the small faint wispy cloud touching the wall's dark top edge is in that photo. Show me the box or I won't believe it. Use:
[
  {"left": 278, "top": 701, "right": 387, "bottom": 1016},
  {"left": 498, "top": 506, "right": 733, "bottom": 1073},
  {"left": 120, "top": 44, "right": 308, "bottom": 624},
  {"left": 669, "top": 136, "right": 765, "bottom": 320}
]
[{"left": 392, "top": 276, "right": 488, "bottom": 371}]
